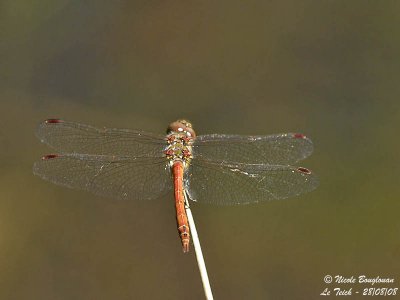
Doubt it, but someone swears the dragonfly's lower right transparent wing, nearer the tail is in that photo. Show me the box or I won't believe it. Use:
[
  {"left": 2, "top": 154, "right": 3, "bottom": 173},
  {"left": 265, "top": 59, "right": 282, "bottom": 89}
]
[{"left": 185, "top": 158, "right": 318, "bottom": 205}]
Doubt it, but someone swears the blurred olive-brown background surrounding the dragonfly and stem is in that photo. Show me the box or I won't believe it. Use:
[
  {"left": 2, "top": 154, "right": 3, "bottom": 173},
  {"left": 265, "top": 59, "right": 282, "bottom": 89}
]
[{"left": 0, "top": 0, "right": 400, "bottom": 299}]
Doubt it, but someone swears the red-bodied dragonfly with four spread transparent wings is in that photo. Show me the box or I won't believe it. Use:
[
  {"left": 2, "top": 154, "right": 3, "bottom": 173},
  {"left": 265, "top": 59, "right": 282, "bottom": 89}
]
[{"left": 33, "top": 119, "right": 318, "bottom": 253}]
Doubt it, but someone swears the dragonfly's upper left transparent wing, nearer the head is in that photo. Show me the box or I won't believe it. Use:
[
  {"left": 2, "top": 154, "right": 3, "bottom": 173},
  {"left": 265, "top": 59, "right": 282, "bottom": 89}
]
[{"left": 36, "top": 119, "right": 166, "bottom": 157}]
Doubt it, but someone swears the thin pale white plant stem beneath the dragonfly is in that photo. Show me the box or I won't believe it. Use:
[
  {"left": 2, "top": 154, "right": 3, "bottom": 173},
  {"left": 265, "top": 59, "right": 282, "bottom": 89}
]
[{"left": 184, "top": 192, "right": 214, "bottom": 300}]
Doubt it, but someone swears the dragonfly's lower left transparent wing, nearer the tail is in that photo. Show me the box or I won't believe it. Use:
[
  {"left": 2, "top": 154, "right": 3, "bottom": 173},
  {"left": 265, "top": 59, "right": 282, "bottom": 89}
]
[{"left": 33, "top": 154, "right": 172, "bottom": 200}]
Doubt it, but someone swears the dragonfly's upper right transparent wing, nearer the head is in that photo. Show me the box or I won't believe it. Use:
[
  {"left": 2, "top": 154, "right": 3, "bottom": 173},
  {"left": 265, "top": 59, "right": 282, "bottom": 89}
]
[{"left": 193, "top": 133, "right": 313, "bottom": 165}]
